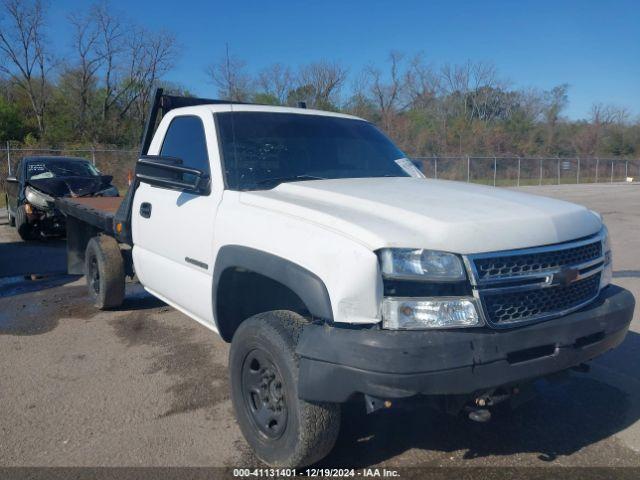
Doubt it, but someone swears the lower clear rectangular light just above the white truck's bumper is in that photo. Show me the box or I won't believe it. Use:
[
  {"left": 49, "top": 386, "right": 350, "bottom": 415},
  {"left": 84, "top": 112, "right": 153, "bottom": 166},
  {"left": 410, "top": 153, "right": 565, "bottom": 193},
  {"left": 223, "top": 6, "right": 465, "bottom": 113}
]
[{"left": 382, "top": 297, "right": 482, "bottom": 330}]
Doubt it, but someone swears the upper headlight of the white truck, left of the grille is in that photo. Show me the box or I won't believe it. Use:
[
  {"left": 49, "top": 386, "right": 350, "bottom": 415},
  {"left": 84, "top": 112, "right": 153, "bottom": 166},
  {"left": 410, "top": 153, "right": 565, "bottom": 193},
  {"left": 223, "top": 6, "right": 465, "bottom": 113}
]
[{"left": 379, "top": 248, "right": 465, "bottom": 281}]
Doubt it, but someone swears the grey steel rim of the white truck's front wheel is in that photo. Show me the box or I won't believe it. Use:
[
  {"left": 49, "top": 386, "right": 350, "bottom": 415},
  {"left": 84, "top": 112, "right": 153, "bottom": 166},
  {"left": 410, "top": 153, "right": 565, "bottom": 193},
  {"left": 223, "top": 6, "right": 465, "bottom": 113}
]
[{"left": 241, "top": 349, "right": 289, "bottom": 440}]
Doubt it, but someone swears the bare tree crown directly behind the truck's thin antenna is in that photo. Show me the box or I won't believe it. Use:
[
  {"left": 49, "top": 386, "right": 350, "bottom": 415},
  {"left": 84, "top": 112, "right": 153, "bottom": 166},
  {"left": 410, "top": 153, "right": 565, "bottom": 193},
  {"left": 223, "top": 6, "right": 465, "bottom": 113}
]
[{"left": 206, "top": 49, "right": 253, "bottom": 102}]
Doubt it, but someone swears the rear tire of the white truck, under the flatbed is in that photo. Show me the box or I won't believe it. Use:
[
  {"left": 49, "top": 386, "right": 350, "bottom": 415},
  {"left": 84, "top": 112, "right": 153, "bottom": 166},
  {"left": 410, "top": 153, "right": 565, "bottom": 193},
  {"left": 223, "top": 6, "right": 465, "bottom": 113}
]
[{"left": 85, "top": 235, "right": 125, "bottom": 310}]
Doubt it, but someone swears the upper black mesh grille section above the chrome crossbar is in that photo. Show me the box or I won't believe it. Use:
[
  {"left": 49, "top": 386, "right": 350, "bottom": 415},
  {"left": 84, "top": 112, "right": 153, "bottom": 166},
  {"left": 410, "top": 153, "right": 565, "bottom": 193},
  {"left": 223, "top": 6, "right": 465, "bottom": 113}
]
[{"left": 473, "top": 239, "right": 602, "bottom": 282}]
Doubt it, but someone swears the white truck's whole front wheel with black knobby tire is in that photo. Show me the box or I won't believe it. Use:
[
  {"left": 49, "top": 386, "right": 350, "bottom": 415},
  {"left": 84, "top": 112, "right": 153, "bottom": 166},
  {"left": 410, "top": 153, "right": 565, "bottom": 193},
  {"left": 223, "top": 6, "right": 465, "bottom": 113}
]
[{"left": 229, "top": 311, "right": 340, "bottom": 468}]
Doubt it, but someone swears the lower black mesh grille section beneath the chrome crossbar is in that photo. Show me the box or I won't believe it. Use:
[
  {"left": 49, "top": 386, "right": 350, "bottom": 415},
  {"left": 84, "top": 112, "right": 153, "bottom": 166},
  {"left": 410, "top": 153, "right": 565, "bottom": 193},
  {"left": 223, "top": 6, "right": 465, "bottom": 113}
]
[{"left": 482, "top": 273, "right": 600, "bottom": 326}]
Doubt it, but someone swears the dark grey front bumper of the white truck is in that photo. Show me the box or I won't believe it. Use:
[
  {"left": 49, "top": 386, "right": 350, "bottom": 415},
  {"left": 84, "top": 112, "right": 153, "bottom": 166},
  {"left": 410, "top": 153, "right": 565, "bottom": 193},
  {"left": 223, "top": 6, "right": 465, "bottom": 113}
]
[{"left": 297, "top": 285, "right": 635, "bottom": 402}]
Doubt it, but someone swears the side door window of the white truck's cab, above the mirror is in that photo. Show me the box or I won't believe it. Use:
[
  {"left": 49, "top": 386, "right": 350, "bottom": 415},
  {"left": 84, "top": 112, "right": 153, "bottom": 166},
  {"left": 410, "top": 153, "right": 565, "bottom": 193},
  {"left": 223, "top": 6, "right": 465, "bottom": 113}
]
[{"left": 160, "top": 115, "right": 211, "bottom": 174}]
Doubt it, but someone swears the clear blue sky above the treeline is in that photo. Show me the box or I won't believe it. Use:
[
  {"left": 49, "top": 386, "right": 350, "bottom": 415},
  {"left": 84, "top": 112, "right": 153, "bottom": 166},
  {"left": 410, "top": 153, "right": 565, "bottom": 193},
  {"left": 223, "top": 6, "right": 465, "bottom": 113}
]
[{"left": 49, "top": 0, "right": 640, "bottom": 119}]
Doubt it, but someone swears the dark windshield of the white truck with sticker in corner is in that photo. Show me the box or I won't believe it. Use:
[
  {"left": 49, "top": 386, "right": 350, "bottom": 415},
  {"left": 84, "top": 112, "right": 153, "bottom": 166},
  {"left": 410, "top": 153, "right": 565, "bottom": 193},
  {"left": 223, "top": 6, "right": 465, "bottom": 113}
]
[{"left": 217, "top": 112, "right": 419, "bottom": 190}]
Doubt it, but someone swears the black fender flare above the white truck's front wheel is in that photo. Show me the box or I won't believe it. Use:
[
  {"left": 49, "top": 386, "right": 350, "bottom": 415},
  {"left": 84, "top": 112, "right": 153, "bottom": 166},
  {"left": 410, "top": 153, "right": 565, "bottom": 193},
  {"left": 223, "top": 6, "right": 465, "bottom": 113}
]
[{"left": 212, "top": 245, "right": 333, "bottom": 331}]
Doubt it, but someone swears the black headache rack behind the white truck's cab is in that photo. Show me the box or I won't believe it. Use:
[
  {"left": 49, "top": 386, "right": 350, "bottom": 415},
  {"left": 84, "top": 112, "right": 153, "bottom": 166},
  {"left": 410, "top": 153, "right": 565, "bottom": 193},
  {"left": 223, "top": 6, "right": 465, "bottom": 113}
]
[{"left": 111, "top": 88, "right": 255, "bottom": 245}]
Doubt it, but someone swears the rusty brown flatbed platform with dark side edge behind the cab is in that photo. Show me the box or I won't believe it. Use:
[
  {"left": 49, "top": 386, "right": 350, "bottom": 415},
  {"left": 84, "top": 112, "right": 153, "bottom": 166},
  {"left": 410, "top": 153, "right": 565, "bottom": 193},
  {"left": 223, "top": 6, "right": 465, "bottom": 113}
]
[{"left": 56, "top": 197, "right": 123, "bottom": 235}]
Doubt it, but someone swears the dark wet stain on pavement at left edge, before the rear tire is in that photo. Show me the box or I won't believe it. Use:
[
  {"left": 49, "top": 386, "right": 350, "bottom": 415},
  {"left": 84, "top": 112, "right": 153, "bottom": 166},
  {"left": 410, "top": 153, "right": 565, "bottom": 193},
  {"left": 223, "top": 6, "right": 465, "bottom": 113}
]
[{"left": 0, "top": 285, "right": 97, "bottom": 335}]
